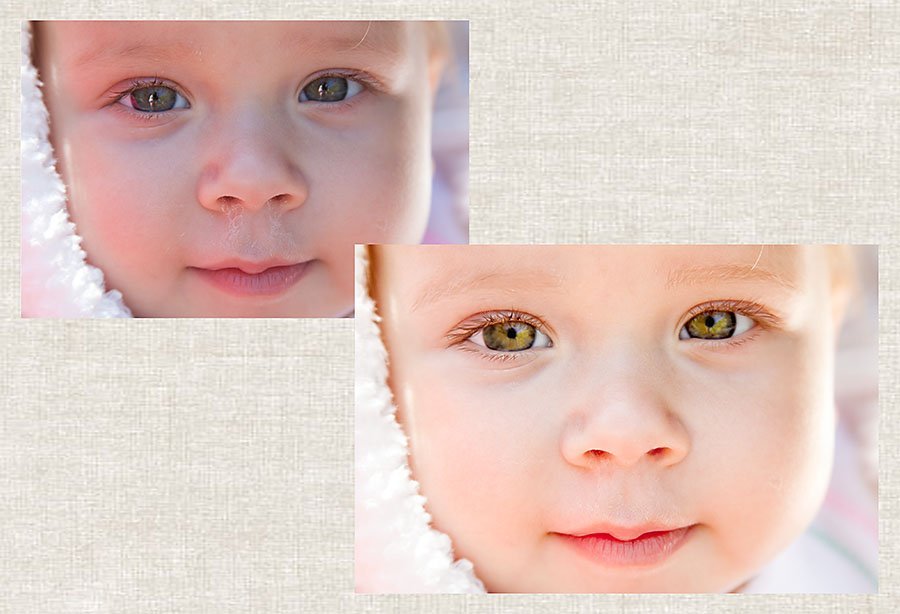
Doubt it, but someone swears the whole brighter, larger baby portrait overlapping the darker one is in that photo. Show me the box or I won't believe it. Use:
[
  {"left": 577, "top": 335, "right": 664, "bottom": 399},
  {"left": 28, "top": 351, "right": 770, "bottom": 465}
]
[{"left": 355, "top": 245, "right": 877, "bottom": 593}]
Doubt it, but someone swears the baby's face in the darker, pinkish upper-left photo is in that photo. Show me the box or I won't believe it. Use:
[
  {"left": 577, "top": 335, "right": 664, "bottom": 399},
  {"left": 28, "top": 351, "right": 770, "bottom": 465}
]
[{"left": 36, "top": 22, "right": 439, "bottom": 317}]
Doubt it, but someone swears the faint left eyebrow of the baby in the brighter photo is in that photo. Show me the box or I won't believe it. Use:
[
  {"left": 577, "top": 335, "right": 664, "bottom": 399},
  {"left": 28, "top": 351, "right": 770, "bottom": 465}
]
[{"left": 410, "top": 271, "right": 563, "bottom": 311}]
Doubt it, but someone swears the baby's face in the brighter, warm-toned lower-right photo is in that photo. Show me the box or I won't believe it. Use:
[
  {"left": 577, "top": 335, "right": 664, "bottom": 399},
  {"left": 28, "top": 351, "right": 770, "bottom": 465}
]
[{"left": 373, "top": 246, "right": 838, "bottom": 592}]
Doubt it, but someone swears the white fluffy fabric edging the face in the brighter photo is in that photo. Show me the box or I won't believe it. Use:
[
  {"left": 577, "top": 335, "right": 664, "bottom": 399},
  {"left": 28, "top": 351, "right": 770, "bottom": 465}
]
[{"left": 355, "top": 246, "right": 484, "bottom": 593}]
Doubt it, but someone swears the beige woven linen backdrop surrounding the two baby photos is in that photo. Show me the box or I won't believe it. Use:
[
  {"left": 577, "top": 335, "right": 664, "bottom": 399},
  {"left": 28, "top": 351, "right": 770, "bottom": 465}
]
[{"left": 0, "top": 0, "right": 900, "bottom": 614}]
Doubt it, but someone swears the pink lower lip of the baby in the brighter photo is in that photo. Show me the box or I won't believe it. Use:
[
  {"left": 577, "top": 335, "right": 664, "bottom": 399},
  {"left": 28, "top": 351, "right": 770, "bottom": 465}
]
[{"left": 556, "top": 525, "right": 693, "bottom": 567}]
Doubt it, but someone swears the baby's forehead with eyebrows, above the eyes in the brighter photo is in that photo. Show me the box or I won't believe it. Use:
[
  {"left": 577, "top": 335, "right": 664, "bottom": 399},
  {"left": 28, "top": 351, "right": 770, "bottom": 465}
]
[{"left": 379, "top": 245, "right": 815, "bottom": 302}]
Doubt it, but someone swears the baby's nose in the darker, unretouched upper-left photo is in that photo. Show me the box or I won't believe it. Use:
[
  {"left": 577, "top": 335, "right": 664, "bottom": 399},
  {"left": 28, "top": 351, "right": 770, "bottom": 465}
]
[{"left": 197, "top": 114, "right": 309, "bottom": 212}]
